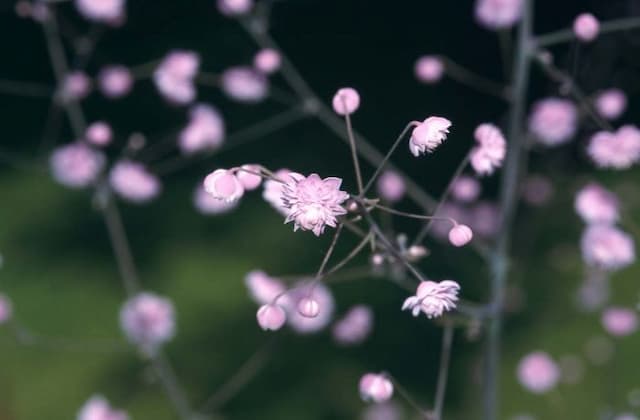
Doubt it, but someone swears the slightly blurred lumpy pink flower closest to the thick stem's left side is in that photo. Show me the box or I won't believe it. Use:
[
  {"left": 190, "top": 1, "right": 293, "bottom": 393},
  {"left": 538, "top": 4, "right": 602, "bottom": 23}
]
[{"left": 470, "top": 123, "right": 507, "bottom": 175}]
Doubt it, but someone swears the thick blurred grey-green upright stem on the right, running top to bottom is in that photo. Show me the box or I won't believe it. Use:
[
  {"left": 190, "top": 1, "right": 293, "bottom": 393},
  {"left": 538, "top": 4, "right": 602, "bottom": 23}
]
[{"left": 483, "top": 0, "right": 533, "bottom": 420}]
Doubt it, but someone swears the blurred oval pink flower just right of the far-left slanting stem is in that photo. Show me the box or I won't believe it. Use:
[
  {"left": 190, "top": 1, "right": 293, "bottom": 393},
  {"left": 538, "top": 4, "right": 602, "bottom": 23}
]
[{"left": 109, "top": 160, "right": 162, "bottom": 204}]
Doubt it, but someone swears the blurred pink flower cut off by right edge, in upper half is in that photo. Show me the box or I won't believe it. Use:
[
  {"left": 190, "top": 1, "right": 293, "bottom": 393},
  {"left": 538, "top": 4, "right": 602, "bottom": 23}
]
[{"left": 587, "top": 125, "right": 640, "bottom": 169}]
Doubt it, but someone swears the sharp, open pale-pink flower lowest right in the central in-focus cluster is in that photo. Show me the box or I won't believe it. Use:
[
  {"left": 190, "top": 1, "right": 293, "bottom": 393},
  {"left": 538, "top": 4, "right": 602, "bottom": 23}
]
[{"left": 402, "top": 280, "right": 460, "bottom": 319}]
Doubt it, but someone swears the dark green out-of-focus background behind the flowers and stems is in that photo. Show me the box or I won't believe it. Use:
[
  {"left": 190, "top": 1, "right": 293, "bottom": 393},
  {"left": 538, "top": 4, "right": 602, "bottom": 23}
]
[{"left": 0, "top": 0, "right": 640, "bottom": 420}]
